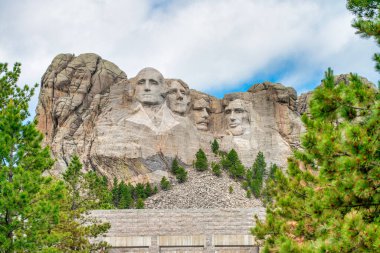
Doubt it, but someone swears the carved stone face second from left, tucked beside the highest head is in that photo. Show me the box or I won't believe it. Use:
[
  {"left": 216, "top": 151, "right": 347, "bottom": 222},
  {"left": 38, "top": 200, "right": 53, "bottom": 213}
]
[{"left": 168, "top": 81, "right": 190, "bottom": 115}]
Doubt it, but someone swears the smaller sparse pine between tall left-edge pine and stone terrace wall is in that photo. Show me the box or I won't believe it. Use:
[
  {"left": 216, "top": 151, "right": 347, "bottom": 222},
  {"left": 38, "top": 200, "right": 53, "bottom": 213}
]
[{"left": 58, "top": 156, "right": 112, "bottom": 252}]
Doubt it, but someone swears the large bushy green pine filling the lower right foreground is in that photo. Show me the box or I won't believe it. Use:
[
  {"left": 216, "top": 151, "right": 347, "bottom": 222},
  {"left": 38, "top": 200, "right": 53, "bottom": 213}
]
[{"left": 252, "top": 68, "right": 380, "bottom": 252}]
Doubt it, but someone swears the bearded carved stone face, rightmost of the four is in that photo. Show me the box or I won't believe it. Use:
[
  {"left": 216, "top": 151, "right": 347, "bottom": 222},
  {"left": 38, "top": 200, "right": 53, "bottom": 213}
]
[{"left": 225, "top": 99, "right": 249, "bottom": 136}]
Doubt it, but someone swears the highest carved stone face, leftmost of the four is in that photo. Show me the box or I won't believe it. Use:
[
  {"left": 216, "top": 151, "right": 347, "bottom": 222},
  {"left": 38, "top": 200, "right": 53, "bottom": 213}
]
[{"left": 135, "top": 68, "right": 165, "bottom": 105}]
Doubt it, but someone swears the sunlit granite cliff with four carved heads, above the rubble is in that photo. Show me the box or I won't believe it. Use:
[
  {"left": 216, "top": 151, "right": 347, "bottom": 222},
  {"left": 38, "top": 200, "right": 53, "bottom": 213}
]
[{"left": 37, "top": 54, "right": 302, "bottom": 182}]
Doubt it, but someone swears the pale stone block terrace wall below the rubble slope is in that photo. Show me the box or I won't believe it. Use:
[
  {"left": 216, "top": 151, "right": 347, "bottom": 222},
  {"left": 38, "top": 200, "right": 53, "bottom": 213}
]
[{"left": 91, "top": 208, "right": 265, "bottom": 253}]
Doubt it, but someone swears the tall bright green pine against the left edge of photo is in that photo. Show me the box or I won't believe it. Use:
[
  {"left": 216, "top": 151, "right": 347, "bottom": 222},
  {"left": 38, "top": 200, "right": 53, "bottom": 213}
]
[{"left": 0, "top": 63, "right": 65, "bottom": 252}]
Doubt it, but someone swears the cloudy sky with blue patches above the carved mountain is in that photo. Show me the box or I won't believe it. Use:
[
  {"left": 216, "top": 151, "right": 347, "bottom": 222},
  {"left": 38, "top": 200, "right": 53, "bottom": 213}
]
[{"left": 0, "top": 0, "right": 378, "bottom": 114}]
